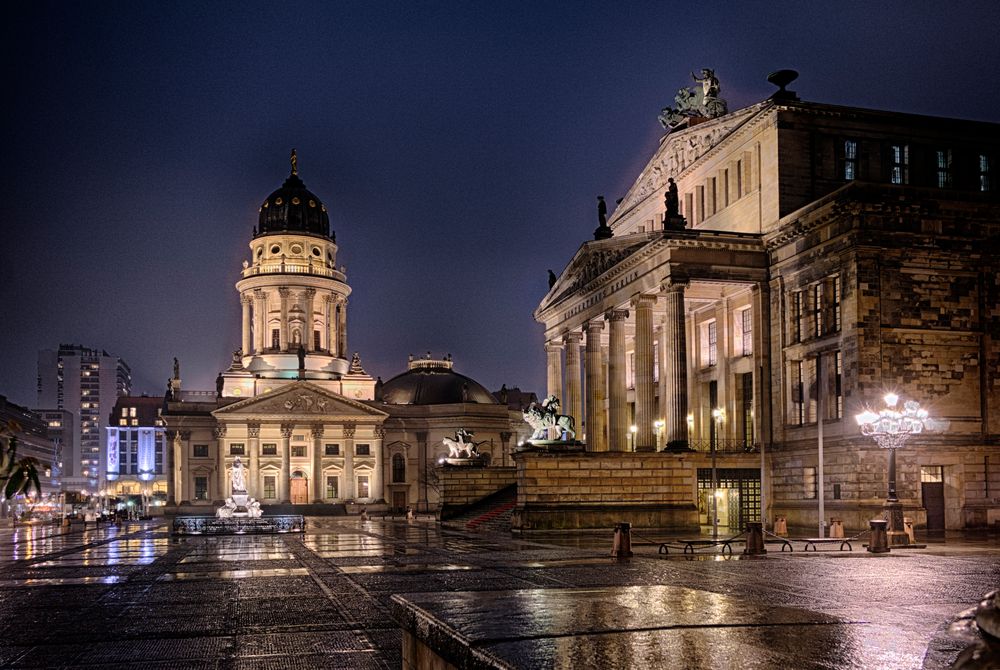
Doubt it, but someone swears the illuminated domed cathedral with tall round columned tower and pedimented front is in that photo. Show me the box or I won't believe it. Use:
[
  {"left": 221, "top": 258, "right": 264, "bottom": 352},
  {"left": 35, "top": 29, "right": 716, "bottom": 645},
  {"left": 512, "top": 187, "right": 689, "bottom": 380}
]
[{"left": 163, "top": 150, "right": 524, "bottom": 514}]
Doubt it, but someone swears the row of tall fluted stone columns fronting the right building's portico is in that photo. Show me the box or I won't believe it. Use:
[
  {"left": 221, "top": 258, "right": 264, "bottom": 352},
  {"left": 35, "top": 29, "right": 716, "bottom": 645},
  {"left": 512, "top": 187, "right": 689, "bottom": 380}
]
[{"left": 545, "top": 281, "right": 688, "bottom": 451}]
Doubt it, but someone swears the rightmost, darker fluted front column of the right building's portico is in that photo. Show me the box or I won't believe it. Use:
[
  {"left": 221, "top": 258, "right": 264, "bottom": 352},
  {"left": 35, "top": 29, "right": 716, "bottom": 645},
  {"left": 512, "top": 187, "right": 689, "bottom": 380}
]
[{"left": 660, "top": 281, "right": 688, "bottom": 446}]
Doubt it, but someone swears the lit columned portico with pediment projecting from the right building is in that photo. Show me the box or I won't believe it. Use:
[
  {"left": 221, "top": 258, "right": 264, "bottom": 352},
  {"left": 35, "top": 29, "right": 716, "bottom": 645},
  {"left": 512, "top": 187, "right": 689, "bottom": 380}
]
[{"left": 535, "top": 230, "right": 768, "bottom": 451}]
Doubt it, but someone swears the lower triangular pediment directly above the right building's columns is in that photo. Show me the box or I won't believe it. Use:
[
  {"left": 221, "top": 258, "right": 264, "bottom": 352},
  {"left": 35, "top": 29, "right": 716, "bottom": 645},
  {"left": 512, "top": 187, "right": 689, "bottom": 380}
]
[{"left": 537, "top": 233, "right": 659, "bottom": 312}]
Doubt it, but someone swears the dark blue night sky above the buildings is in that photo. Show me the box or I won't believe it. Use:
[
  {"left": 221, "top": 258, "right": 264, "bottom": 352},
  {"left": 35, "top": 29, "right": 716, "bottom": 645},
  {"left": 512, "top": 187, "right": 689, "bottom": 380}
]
[{"left": 0, "top": 0, "right": 1000, "bottom": 406}]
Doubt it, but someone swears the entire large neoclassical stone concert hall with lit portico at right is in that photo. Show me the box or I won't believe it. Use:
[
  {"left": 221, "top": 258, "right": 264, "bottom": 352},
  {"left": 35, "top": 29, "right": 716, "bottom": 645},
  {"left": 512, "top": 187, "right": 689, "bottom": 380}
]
[{"left": 535, "top": 80, "right": 1000, "bottom": 530}]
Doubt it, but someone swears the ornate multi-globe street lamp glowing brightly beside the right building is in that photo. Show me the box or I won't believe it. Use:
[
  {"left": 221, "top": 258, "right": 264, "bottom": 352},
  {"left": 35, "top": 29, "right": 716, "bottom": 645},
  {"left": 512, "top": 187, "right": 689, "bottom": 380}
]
[{"left": 854, "top": 393, "right": 928, "bottom": 545}]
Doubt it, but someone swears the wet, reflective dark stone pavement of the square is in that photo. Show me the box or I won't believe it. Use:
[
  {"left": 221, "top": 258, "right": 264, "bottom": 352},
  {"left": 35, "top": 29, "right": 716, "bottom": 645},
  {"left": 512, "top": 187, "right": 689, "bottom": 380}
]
[{"left": 0, "top": 518, "right": 1000, "bottom": 669}]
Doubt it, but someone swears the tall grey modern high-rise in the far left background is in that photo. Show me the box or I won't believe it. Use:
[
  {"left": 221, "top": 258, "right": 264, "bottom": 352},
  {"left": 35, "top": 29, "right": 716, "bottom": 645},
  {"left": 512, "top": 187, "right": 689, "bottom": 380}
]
[{"left": 37, "top": 344, "right": 132, "bottom": 488}]
